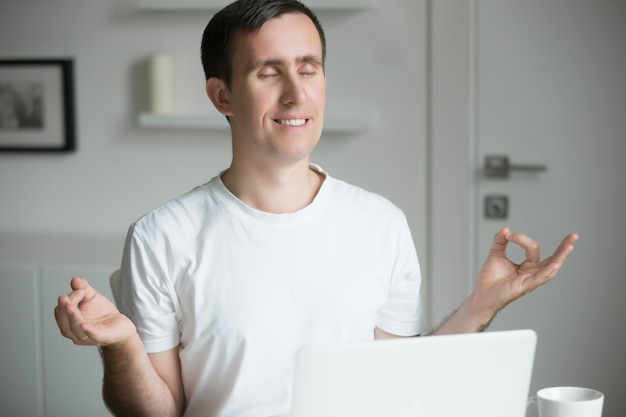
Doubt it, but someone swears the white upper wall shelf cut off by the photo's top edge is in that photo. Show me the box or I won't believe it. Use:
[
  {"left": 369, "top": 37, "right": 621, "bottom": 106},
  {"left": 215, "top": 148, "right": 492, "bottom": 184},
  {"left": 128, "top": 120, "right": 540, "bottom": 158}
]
[{"left": 136, "top": 0, "right": 377, "bottom": 11}]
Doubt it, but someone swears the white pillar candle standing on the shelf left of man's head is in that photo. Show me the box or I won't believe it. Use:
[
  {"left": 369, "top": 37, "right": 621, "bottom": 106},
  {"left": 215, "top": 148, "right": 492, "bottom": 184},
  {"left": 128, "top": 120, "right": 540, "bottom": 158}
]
[{"left": 149, "top": 53, "right": 174, "bottom": 114}]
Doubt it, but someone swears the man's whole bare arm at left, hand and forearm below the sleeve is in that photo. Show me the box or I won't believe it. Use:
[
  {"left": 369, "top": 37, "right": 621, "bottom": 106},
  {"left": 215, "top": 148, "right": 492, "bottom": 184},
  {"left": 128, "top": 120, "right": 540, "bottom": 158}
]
[{"left": 54, "top": 277, "right": 185, "bottom": 416}]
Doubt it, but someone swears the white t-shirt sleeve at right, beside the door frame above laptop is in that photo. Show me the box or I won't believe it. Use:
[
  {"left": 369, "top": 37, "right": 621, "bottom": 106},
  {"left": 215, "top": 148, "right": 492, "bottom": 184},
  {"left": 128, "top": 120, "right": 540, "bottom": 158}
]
[{"left": 376, "top": 214, "right": 425, "bottom": 336}]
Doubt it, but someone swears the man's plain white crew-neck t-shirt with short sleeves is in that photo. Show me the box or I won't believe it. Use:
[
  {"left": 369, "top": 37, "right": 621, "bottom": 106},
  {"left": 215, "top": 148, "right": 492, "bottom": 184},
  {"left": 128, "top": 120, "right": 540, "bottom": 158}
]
[{"left": 120, "top": 165, "right": 424, "bottom": 417}]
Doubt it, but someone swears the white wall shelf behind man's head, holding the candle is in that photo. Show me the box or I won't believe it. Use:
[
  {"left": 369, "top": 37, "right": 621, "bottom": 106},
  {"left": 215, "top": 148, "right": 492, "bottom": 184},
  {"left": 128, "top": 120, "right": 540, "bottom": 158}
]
[{"left": 138, "top": 103, "right": 378, "bottom": 133}]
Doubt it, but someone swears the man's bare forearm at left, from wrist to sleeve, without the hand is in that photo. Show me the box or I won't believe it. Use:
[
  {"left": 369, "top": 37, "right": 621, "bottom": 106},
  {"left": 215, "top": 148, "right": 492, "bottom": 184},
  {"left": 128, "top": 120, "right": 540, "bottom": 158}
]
[{"left": 102, "top": 335, "right": 182, "bottom": 417}]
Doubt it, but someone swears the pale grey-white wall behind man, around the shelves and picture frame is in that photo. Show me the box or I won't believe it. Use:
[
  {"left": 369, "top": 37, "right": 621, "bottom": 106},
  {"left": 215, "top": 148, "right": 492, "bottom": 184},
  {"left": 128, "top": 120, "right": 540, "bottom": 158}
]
[{"left": 0, "top": 0, "right": 426, "bottom": 242}]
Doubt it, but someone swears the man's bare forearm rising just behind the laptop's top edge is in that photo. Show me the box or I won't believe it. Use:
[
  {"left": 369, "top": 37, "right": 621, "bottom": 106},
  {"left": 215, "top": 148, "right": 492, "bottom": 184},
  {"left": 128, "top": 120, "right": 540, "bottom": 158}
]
[{"left": 430, "top": 295, "right": 497, "bottom": 335}]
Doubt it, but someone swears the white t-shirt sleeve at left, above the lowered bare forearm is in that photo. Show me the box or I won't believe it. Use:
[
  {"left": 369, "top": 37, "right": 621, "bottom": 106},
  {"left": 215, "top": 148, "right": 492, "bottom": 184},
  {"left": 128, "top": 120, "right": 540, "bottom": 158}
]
[{"left": 118, "top": 224, "right": 180, "bottom": 353}]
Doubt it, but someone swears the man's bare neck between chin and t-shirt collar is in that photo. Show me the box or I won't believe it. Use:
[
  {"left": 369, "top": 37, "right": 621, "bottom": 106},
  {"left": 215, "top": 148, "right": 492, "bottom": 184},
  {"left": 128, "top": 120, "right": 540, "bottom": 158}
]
[{"left": 222, "top": 160, "right": 324, "bottom": 214}]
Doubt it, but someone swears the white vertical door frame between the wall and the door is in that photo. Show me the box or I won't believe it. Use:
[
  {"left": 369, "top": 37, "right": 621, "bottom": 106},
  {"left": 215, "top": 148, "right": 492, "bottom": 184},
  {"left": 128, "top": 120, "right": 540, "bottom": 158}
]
[{"left": 425, "top": 0, "right": 480, "bottom": 326}]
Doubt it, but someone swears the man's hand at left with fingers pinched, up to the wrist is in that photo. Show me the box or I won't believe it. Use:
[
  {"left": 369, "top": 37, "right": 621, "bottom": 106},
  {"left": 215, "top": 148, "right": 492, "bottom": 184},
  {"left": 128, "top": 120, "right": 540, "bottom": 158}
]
[{"left": 54, "top": 277, "right": 137, "bottom": 346}]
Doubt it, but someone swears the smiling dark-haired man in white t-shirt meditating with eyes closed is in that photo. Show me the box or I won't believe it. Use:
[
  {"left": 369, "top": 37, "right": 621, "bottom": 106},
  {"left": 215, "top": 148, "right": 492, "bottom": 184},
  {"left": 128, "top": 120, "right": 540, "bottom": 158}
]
[{"left": 55, "top": 0, "right": 577, "bottom": 417}]
